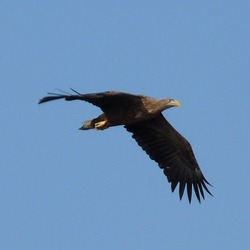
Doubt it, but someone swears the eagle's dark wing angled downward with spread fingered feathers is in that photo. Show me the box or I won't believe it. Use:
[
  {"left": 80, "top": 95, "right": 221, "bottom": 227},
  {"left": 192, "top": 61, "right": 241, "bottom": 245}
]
[{"left": 125, "top": 114, "right": 212, "bottom": 202}]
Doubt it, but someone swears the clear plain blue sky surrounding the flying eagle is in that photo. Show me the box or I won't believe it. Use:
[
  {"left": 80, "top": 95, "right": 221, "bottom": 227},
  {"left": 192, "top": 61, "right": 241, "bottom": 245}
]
[{"left": 0, "top": 0, "right": 250, "bottom": 250}]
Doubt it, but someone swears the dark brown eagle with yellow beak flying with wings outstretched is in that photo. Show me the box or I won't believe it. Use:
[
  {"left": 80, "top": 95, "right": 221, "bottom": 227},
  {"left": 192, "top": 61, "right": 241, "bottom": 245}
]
[{"left": 39, "top": 89, "right": 212, "bottom": 203}]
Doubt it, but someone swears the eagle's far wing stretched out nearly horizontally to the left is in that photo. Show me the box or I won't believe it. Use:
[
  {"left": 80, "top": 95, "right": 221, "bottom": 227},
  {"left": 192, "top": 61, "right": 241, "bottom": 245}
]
[{"left": 38, "top": 89, "right": 141, "bottom": 112}]
